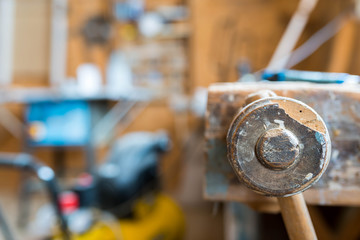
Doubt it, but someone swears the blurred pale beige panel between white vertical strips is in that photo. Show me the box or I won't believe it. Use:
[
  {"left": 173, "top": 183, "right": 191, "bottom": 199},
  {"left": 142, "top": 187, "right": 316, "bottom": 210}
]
[{"left": 13, "top": 0, "right": 51, "bottom": 84}]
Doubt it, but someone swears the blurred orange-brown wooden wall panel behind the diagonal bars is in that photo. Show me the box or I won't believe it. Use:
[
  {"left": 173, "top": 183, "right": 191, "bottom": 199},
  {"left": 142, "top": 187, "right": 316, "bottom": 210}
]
[{"left": 189, "top": 0, "right": 350, "bottom": 86}]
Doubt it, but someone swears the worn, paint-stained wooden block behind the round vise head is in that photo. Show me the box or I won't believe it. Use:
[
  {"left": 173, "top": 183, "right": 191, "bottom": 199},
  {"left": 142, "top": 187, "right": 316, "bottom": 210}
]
[{"left": 204, "top": 83, "right": 360, "bottom": 206}]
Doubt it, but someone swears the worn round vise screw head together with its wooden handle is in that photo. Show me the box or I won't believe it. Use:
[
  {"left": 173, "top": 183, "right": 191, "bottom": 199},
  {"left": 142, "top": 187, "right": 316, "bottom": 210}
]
[{"left": 227, "top": 91, "right": 331, "bottom": 240}]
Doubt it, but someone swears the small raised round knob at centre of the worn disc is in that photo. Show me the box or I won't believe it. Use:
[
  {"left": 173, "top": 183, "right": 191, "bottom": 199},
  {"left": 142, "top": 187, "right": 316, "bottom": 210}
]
[{"left": 255, "top": 128, "right": 300, "bottom": 170}]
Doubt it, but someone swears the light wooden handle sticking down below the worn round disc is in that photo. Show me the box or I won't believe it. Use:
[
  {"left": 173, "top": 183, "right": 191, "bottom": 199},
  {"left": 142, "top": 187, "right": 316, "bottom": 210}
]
[{"left": 278, "top": 193, "right": 317, "bottom": 240}]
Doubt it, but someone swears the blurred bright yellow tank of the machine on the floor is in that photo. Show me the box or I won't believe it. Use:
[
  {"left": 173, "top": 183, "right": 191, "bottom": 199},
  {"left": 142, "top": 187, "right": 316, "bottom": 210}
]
[{"left": 55, "top": 193, "right": 185, "bottom": 240}]
